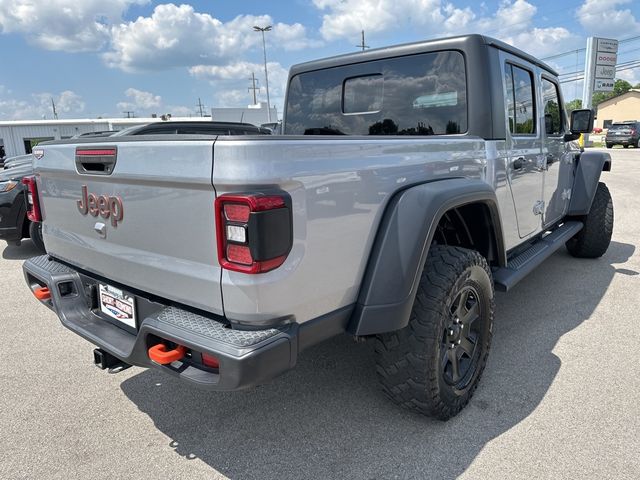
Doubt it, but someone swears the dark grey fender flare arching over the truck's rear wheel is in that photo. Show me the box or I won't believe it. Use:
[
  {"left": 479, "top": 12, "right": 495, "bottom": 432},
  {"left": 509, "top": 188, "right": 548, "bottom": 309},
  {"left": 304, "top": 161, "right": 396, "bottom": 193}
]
[{"left": 347, "top": 178, "right": 506, "bottom": 336}]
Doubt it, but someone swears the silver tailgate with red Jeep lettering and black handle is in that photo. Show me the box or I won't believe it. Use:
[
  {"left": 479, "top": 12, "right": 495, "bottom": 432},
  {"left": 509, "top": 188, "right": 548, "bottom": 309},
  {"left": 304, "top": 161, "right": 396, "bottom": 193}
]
[{"left": 36, "top": 139, "right": 223, "bottom": 314}]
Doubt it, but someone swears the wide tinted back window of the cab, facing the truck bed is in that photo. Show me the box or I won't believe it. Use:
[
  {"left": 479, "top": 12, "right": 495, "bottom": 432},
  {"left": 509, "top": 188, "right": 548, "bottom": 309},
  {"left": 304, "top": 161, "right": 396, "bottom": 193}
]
[{"left": 285, "top": 51, "right": 467, "bottom": 135}]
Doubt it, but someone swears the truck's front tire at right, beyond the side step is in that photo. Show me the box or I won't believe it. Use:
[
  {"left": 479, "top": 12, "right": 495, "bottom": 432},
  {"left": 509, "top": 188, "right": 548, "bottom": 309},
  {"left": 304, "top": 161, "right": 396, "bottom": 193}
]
[{"left": 566, "top": 182, "right": 613, "bottom": 258}]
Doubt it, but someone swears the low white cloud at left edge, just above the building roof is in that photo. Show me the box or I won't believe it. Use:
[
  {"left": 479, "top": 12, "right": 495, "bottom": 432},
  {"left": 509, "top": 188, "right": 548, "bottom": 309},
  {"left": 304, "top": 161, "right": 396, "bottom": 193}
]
[{"left": 0, "top": 89, "right": 85, "bottom": 120}]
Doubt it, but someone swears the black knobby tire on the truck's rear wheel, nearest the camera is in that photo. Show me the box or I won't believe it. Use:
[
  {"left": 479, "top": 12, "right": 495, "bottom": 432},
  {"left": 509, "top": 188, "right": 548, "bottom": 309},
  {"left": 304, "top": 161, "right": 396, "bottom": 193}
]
[{"left": 375, "top": 245, "right": 495, "bottom": 420}]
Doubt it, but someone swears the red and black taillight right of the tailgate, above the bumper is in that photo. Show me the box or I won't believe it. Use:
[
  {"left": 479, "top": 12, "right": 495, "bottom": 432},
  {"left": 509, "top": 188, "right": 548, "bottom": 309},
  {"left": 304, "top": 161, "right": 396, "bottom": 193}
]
[{"left": 215, "top": 194, "right": 292, "bottom": 273}]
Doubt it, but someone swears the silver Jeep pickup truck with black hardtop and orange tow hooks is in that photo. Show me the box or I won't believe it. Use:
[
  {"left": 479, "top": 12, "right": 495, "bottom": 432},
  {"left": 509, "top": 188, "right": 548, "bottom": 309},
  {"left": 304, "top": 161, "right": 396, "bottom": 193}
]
[{"left": 24, "top": 35, "right": 613, "bottom": 419}]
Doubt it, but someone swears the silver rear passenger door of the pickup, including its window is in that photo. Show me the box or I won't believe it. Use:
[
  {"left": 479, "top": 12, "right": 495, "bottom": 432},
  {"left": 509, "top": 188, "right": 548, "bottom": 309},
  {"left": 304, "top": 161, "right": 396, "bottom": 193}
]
[{"left": 501, "top": 52, "right": 544, "bottom": 238}]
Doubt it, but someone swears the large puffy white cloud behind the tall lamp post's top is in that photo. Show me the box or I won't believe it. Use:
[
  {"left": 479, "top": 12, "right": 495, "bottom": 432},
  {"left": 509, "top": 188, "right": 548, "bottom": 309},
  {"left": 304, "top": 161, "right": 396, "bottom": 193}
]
[{"left": 103, "top": 4, "right": 313, "bottom": 71}]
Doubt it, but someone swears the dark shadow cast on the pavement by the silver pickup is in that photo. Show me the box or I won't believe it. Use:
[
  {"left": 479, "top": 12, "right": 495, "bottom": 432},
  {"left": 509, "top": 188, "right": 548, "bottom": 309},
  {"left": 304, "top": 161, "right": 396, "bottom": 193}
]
[{"left": 121, "top": 242, "right": 637, "bottom": 479}]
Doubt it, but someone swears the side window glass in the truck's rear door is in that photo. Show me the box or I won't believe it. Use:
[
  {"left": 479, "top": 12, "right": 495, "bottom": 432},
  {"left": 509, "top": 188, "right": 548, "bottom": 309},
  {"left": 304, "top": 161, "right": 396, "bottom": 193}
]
[{"left": 504, "top": 63, "right": 536, "bottom": 135}]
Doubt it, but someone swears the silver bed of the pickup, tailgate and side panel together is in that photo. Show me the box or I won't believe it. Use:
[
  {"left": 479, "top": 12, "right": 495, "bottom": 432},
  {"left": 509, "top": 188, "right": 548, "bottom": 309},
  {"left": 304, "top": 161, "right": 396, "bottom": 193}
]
[{"left": 37, "top": 136, "right": 500, "bottom": 325}]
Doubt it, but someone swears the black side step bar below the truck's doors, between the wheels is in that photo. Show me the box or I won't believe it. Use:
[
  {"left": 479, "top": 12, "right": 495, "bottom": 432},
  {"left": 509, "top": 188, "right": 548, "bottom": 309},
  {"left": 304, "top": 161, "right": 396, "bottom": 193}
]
[{"left": 493, "top": 221, "right": 583, "bottom": 292}]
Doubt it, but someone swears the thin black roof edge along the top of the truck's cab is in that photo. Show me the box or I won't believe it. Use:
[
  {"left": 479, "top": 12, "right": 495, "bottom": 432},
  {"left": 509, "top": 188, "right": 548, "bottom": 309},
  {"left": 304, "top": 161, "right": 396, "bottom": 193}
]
[{"left": 289, "top": 34, "right": 558, "bottom": 77}]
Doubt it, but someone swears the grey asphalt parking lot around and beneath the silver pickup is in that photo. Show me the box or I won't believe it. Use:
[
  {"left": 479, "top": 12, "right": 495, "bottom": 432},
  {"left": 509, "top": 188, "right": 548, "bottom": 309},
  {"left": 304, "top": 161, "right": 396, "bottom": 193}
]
[{"left": 0, "top": 148, "right": 640, "bottom": 479}]
